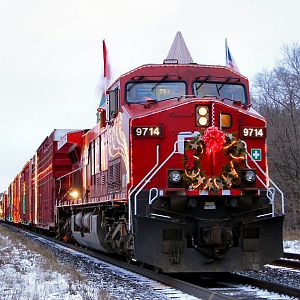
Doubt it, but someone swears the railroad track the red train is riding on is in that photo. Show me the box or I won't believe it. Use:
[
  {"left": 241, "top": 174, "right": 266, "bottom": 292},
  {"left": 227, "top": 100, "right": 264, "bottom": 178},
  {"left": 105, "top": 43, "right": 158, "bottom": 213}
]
[{"left": 1, "top": 221, "right": 300, "bottom": 300}]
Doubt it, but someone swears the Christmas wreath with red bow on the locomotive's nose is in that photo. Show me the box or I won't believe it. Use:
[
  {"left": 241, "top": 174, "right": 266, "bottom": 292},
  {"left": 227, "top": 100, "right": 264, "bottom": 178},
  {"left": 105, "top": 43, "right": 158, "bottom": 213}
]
[{"left": 183, "top": 126, "right": 246, "bottom": 192}]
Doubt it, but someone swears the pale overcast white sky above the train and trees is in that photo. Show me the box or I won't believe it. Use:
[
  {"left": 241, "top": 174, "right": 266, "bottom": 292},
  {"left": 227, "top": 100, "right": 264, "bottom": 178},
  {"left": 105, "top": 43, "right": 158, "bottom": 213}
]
[{"left": 0, "top": 0, "right": 300, "bottom": 192}]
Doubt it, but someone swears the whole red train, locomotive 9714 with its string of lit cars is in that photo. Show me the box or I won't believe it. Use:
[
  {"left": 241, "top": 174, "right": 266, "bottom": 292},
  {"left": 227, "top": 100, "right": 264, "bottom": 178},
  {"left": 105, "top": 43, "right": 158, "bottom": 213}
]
[{"left": 0, "top": 35, "right": 284, "bottom": 272}]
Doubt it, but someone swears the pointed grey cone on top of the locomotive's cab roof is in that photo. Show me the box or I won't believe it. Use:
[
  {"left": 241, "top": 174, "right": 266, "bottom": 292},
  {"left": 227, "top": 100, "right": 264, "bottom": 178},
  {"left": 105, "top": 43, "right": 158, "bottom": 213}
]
[{"left": 164, "top": 31, "right": 194, "bottom": 64}]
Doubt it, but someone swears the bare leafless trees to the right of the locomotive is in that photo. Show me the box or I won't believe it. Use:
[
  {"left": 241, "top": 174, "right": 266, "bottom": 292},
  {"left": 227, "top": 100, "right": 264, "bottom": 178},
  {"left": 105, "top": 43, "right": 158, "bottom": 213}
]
[{"left": 252, "top": 44, "right": 300, "bottom": 231}]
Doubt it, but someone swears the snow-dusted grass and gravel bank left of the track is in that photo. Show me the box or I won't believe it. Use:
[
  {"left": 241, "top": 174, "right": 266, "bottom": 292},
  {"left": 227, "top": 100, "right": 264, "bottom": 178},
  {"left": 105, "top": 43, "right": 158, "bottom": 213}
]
[{"left": 0, "top": 224, "right": 173, "bottom": 300}]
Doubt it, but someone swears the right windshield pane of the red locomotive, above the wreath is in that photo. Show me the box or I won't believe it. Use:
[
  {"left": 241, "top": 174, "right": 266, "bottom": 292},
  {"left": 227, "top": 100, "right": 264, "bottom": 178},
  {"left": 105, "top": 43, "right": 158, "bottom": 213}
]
[{"left": 193, "top": 82, "right": 246, "bottom": 104}]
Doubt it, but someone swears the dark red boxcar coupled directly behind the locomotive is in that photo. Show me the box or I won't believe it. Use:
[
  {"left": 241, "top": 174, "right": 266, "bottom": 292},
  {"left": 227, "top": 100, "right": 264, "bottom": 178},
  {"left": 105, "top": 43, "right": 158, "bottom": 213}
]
[{"left": 31, "top": 129, "right": 83, "bottom": 232}]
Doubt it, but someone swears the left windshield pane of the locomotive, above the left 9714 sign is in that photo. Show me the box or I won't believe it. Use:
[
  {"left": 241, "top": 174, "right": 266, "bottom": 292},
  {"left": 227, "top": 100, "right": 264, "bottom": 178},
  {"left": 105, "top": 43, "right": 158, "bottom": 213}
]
[{"left": 127, "top": 81, "right": 186, "bottom": 103}]
